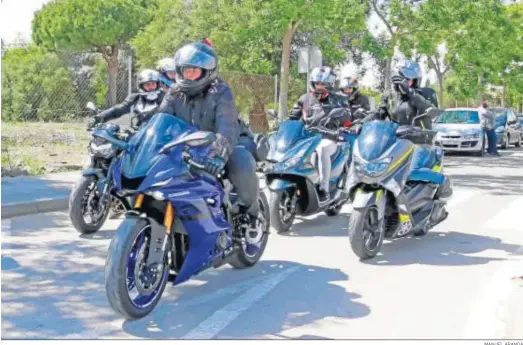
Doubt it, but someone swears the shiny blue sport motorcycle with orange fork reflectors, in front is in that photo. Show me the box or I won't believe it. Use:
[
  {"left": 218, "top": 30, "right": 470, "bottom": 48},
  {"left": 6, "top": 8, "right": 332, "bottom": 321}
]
[{"left": 105, "top": 113, "right": 270, "bottom": 319}]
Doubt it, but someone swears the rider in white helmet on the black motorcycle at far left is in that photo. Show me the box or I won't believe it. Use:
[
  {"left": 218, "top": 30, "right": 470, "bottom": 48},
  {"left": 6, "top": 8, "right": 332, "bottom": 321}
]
[{"left": 88, "top": 69, "right": 165, "bottom": 127}]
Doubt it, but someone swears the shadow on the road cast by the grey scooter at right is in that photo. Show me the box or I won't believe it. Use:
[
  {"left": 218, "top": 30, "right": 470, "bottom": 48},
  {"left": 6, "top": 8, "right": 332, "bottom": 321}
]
[{"left": 362, "top": 231, "right": 523, "bottom": 266}]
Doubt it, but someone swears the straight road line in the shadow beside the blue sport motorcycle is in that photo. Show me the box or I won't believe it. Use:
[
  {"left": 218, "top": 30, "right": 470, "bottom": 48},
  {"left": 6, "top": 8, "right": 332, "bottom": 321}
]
[{"left": 183, "top": 266, "right": 299, "bottom": 339}]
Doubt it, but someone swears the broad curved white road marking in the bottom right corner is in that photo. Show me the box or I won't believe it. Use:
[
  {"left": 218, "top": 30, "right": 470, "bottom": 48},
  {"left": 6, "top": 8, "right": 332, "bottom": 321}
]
[{"left": 463, "top": 259, "right": 523, "bottom": 339}]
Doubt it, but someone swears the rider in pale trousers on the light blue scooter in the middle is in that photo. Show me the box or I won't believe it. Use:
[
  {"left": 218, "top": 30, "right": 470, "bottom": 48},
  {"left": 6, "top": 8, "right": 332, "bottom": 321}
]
[{"left": 289, "top": 66, "right": 347, "bottom": 202}]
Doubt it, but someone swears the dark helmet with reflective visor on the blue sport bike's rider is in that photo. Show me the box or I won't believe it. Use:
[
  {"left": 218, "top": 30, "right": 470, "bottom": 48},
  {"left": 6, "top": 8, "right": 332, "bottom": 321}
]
[{"left": 174, "top": 42, "right": 218, "bottom": 96}]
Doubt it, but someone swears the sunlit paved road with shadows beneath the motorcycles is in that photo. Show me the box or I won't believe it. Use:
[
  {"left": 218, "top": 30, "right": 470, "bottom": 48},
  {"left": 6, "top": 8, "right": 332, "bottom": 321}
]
[{"left": 2, "top": 148, "right": 523, "bottom": 339}]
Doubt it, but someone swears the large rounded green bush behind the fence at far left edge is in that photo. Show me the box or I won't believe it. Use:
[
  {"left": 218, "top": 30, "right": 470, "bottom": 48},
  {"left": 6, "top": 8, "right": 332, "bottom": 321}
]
[{"left": 2, "top": 45, "right": 78, "bottom": 121}]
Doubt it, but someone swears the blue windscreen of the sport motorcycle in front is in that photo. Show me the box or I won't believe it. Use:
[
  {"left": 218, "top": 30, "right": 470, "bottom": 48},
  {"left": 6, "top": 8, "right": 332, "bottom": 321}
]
[{"left": 122, "top": 113, "right": 189, "bottom": 178}]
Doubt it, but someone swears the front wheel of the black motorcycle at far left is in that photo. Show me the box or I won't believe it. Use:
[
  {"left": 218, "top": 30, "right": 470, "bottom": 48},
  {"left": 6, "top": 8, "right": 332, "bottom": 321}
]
[{"left": 69, "top": 175, "right": 111, "bottom": 234}]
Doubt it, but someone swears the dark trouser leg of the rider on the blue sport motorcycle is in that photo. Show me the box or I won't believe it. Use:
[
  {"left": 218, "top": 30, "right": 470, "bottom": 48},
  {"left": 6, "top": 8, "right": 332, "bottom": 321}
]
[{"left": 225, "top": 146, "right": 260, "bottom": 215}]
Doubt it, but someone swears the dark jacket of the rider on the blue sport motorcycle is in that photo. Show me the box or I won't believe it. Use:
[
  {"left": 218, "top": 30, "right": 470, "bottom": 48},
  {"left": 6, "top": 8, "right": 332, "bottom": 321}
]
[{"left": 158, "top": 79, "right": 238, "bottom": 155}]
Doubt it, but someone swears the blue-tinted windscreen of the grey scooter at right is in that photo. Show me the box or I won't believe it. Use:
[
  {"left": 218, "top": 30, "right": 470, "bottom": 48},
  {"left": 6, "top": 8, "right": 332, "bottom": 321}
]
[{"left": 356, "top": 121, "right": 398, "bottom": 161}]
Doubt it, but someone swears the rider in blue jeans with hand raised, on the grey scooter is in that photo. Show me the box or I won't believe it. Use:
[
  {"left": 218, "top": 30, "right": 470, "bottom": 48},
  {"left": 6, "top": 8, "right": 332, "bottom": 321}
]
[{"left": 366, "top": 60, "right": 452, "bottom": 198}]
